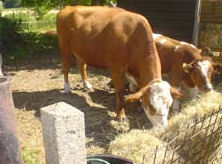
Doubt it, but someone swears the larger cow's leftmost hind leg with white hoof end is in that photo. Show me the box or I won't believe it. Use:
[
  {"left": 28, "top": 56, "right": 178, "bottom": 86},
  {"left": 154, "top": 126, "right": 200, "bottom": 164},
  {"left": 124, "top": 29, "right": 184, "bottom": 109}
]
[{"left": 61, "top": 50, "right": 71, "bottom": 93}]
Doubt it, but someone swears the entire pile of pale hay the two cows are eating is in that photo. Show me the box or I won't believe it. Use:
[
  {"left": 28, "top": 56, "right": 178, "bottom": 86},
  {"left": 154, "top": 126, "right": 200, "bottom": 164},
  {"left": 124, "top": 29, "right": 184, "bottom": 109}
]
[{"left": 108, "top": 91, "right": 222, "bottom": 164}]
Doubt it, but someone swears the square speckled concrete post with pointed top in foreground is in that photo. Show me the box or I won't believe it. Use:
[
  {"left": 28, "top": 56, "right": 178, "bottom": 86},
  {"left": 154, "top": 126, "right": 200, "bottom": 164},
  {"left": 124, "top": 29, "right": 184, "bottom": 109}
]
[{"left": 41, "top": 102, "right": 86, "bottom": 164}]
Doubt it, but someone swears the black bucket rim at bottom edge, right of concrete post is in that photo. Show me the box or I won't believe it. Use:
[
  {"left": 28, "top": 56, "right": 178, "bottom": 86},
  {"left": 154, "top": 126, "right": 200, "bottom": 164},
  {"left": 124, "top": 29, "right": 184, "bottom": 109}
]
[{"left": 87, "top": 154, "right": 136, "bottom": 164}]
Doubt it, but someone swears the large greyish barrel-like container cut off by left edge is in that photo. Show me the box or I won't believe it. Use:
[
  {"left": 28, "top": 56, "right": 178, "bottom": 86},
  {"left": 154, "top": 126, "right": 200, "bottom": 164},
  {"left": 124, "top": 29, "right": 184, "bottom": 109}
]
[{"left": 0, "top": 76, "right": 23, "bottom": 164}]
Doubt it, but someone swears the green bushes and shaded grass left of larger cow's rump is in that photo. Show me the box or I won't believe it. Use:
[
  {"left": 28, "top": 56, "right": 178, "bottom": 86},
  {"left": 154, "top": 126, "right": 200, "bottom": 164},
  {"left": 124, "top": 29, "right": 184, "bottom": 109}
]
[{"left": 0, "top": 8, "right": 57, "bottom": 62}]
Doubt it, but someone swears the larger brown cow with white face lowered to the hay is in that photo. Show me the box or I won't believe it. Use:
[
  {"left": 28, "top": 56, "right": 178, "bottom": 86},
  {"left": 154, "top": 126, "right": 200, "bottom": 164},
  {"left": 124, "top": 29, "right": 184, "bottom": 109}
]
[{"left": 57, "top": 6, "right": 181, "bottom": 125}]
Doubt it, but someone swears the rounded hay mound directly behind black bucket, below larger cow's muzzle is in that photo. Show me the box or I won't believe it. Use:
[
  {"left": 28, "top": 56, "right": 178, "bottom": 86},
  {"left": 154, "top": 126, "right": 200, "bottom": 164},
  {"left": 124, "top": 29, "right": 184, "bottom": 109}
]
[{"left": 108, "top": 130, "right": 182, "bottom": 164}]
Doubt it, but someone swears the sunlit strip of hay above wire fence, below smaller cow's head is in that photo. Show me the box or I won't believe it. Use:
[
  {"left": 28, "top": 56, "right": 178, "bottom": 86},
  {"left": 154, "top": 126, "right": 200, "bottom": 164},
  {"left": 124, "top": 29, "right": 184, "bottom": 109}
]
[{"left": 157, "top": 91, "right": 222, "bottom": 139}]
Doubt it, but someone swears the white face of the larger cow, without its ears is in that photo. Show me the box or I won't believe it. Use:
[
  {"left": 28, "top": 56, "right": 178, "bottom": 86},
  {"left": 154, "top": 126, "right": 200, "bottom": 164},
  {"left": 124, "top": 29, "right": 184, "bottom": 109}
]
[{"left": 142, "top": 81, "right": 173, "bottom": 126}]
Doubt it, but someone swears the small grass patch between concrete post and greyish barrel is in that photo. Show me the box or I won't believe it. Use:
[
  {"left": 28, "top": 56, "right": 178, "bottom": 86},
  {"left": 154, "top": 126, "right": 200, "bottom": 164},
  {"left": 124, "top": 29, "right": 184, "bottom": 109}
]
[{"left": 22, "top": 147, "right": 39, "bottom": 164}]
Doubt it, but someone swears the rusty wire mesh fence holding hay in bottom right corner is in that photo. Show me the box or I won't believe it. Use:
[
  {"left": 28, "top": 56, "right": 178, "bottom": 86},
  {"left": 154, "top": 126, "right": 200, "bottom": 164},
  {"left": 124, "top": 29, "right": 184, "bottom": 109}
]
[{"left": 142, "top": 108, "right": 222, "bottom": 164}]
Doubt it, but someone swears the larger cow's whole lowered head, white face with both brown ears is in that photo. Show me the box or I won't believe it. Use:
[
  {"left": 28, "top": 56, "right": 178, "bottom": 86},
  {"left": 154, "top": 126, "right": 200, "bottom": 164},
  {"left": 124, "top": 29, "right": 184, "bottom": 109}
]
[{"left": 125, "top": 80, "right": 183, "bottom": 126}]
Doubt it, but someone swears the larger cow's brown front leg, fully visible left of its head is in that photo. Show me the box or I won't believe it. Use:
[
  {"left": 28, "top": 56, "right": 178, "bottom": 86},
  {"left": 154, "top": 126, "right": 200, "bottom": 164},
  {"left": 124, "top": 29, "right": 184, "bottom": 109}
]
[{"left": 111, "top": 69, "right": 126, "bottom": 119}]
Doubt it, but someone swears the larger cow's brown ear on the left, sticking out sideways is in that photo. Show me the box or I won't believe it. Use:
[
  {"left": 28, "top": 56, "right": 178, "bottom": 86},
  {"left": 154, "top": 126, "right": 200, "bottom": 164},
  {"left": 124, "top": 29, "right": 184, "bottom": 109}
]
[{"left": 125, "top": 84, "right": 150, "bottom": 102}]
